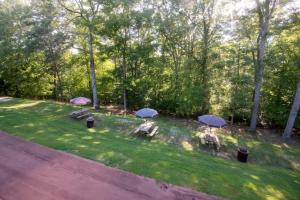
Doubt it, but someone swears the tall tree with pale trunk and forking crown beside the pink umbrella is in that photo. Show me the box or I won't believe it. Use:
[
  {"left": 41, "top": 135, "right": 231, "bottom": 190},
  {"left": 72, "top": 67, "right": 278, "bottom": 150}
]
[{"left": 59, "top": 0, "right": 100, "bottom": 109}]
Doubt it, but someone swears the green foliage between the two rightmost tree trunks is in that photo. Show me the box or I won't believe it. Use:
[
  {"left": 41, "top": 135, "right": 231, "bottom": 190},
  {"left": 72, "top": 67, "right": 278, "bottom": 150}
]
[{"left": 262, "top": 14, "right": 300, "bottom": 127}]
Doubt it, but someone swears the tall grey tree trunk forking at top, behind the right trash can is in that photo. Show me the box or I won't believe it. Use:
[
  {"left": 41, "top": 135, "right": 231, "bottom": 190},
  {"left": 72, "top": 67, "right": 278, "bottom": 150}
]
[{"left": 249, "top": 0, "right": 276, "bottom": 132}]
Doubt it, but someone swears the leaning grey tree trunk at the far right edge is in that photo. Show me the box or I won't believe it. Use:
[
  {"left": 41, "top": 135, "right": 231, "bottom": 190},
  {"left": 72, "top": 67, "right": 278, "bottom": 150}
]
[{"left": 282, "top": 77, "right": 300, "bottom": 139}]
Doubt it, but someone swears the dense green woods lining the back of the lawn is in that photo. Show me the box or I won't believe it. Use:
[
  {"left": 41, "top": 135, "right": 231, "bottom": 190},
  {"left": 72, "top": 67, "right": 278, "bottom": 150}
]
[{"left": 0, "top": 0, "right": 300, "bottom": 137}]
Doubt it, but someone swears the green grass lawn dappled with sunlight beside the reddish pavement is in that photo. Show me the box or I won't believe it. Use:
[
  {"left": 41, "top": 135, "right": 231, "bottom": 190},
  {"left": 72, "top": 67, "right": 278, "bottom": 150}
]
[{"left": 0, "top": 99, "right": 300, "bottom": 200}]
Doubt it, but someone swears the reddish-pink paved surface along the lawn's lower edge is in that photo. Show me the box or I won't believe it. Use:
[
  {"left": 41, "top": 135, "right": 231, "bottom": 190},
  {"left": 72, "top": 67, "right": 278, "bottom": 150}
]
[{"left": 0, "top": 132, "right": 219, "bottom": 200}]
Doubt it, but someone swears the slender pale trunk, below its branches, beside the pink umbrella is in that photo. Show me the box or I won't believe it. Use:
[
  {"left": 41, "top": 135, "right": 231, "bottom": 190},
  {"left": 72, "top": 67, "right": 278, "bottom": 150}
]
[{"left": 88, "top": 28, "right": 99, "bottom": 109}]
